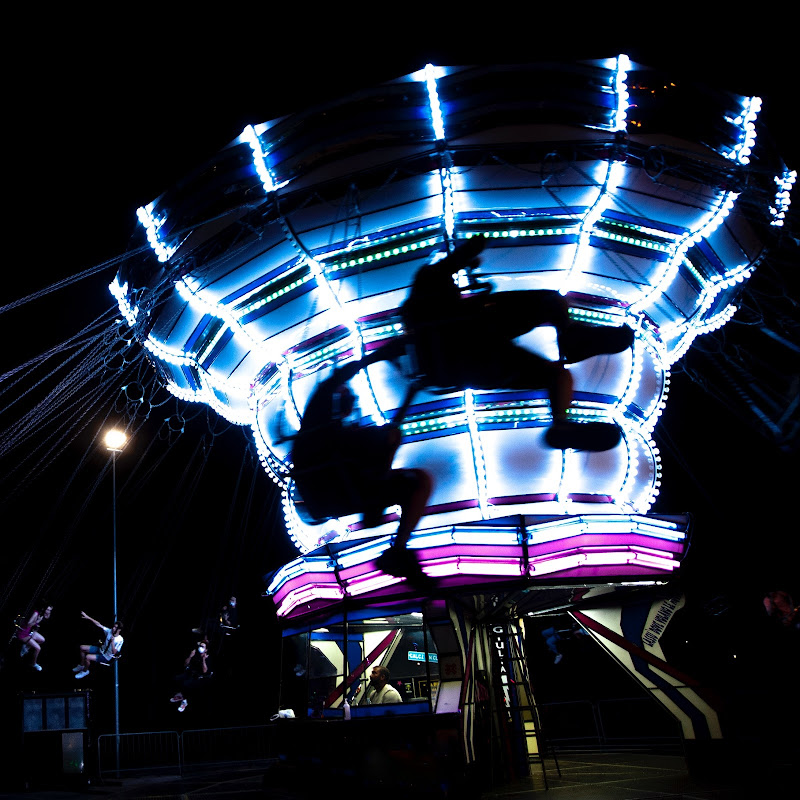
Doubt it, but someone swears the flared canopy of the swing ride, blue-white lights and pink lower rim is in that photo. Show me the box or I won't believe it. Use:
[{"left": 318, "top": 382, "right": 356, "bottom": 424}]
[{"left": 111, "top": 56, "right": 794, "bottom": 613}]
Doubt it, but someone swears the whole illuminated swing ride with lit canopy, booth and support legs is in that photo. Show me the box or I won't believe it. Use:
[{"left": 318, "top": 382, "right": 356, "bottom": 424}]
[{"left": 111, "top": 55, "right": 796, "bottom": 788}]
